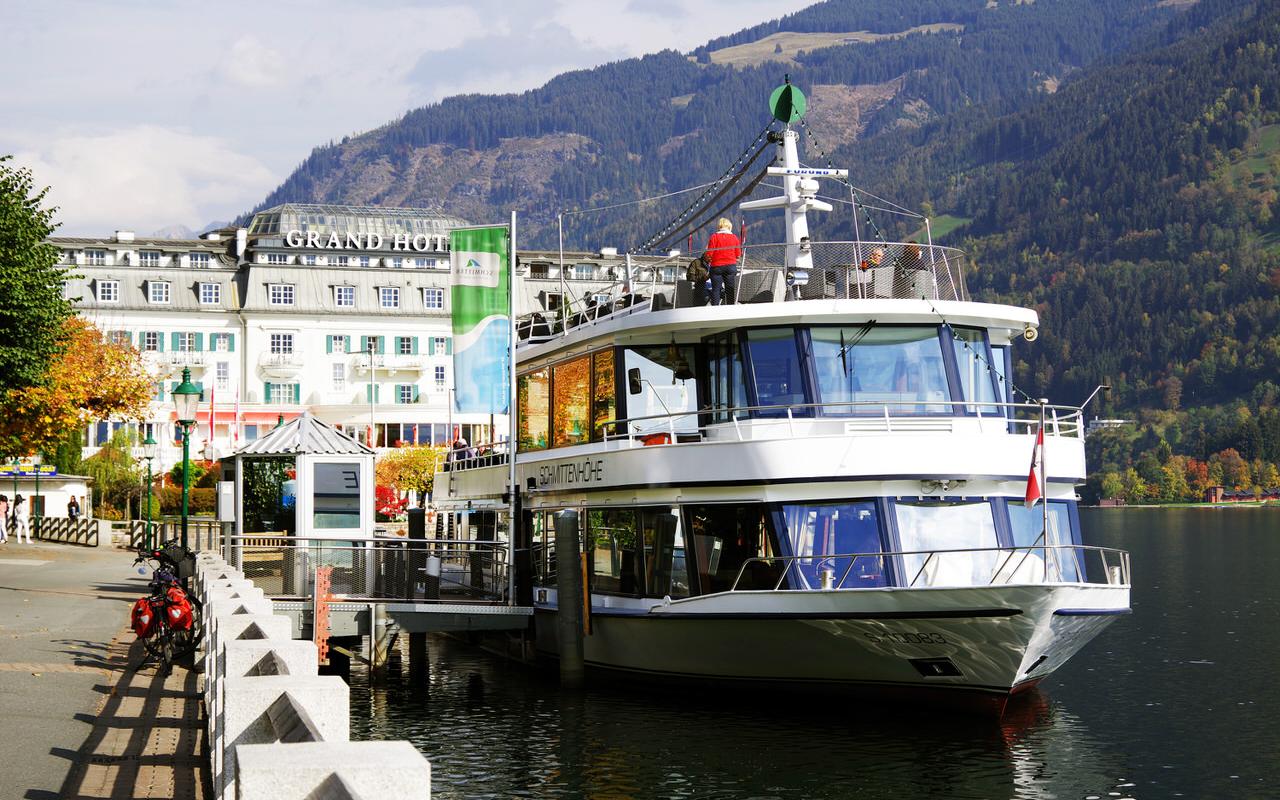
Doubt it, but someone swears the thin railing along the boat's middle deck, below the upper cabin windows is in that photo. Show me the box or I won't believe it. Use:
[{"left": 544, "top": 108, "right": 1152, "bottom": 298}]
[{"left": 602, "top": 398, "right": 1085, "bottom": 445}]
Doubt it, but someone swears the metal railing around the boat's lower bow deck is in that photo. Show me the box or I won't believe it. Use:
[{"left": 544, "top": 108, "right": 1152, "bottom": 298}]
[{"left": 730, "top": 543, "right": 1130, "bottom": 591}]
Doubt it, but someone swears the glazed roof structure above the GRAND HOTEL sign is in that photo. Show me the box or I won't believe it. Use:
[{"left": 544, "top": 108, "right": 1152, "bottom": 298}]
[{"left": 248, "top": 202, "right": 470, "bottom": 239}]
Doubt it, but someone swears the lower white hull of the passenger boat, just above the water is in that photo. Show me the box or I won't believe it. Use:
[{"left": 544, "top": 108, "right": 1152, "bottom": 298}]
[{"left": 538, "top": 584, "right": 1129, "bottom": 698}]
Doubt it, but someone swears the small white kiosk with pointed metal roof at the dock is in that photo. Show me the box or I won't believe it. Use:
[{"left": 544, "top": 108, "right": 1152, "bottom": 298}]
[{"left": 236, "top": 411, "right": 374, "bottom": 540}]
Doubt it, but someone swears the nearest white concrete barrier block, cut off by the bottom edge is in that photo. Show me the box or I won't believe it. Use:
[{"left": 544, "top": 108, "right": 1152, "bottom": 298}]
[{"left": 236, "top": 741, "right": 431, "bottom": 800}]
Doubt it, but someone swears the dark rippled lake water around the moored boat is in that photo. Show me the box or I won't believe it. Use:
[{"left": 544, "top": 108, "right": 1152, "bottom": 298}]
[{"left": 351, "top": 508, "right": 1280, "bottom": 800}]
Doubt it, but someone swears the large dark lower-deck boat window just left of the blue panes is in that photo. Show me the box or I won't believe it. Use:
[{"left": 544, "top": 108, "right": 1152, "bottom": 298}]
[{"left": 685, "top": 503, "right": 787, "bottom": 594}]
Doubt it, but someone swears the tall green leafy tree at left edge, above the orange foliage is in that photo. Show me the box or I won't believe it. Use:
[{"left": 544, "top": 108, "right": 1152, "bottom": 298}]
[{"left": 0, "top": 156, "right": 72, "bottom": 422}]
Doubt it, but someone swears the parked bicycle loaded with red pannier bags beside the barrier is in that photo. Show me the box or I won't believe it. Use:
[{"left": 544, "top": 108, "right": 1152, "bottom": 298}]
[{"left": 131, "top": 541, "right": 204, "bottom": 666}]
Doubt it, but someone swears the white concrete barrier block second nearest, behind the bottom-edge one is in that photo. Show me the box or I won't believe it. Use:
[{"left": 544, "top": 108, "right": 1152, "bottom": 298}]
[{"left": 221, "top": 675, "right": 351, "bottom": 800}]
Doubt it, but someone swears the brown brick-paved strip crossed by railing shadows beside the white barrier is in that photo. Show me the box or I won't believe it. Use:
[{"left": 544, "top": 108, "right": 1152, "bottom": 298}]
[{"left": 60, "top": 628, "right": 212, "bottom": 800}]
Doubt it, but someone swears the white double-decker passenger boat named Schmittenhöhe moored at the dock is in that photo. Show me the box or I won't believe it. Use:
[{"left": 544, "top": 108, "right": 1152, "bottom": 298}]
[{"left": 435, "top": 82, "right": 1130, "bottom": 709}]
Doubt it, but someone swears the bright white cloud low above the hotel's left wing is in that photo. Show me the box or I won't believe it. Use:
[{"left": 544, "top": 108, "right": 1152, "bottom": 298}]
[{"left": 14, "top": 125, "right": 280, "bottom": 236}]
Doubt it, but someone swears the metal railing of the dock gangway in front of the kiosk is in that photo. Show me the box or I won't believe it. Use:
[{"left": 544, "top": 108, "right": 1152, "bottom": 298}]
[{"left": 224, "top": 534, "right": 508, "bottom": 603}]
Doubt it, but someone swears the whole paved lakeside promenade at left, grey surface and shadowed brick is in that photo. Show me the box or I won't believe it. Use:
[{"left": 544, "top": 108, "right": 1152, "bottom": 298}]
[{"left": 0, "top": 539, "right": 207, "bottom": 800}]
